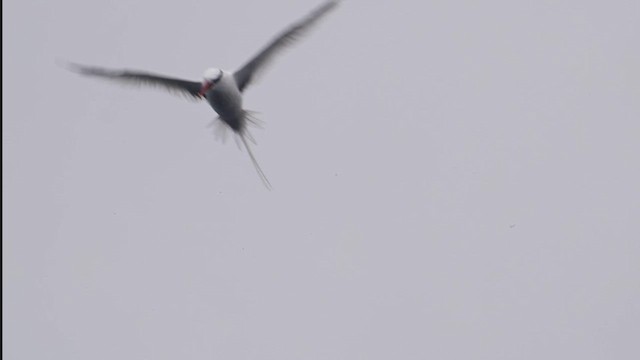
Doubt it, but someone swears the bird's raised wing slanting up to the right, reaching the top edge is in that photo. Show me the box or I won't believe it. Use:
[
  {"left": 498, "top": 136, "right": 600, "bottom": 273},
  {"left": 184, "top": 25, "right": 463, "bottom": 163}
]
[{"left": 233, "top": 0, "right": 339, "bottom": 91}]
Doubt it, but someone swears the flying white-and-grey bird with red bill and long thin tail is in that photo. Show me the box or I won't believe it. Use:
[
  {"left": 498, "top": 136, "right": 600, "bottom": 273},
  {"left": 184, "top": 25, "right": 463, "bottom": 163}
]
[{"left": 64, "top": 0, "right": 340, "bottom": 190}]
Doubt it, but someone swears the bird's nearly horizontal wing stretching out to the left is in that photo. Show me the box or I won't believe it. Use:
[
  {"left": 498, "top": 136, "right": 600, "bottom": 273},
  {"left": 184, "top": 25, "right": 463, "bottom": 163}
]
[{"left": 67, "top": 63, "right": 201, "bottom": 99}]
